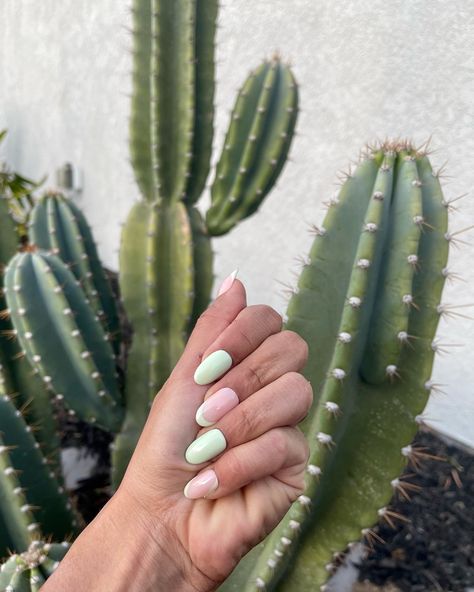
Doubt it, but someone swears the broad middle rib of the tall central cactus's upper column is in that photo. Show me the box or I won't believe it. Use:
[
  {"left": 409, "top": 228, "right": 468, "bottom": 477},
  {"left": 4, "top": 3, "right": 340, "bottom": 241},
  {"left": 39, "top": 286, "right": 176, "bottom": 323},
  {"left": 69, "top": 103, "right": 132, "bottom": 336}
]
[{"left": 151, "top": 0, "right": 195, "bottom": 203}]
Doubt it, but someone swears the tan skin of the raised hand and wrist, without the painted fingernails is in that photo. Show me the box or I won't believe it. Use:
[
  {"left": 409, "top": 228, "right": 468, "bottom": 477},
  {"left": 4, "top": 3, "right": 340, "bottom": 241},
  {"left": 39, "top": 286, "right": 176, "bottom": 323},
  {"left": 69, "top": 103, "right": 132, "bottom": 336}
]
[{"left": 43, "top": 280, "right": 312, "bottom": 592}]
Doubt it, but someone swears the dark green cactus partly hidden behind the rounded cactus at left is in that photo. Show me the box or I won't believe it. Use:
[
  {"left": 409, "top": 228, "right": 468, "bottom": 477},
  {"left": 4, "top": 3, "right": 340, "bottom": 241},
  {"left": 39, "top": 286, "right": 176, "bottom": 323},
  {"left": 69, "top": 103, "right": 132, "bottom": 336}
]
[{"left": 29, "top": 191, "right": 120, "bottom": 353}]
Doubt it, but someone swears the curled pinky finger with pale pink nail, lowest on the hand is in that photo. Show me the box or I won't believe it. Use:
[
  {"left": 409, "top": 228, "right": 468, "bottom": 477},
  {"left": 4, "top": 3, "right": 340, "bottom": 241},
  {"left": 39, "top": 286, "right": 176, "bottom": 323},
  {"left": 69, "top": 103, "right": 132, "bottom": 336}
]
[{"left": 184, "top": 427, "right": 309, "bottom": 499}]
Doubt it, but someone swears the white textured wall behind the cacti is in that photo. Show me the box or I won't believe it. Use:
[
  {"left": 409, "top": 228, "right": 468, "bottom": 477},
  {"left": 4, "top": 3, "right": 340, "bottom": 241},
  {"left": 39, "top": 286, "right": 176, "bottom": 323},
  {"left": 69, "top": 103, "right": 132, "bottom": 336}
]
[{"left": 0, "top": 0, "right": 474, "bottom": 443}]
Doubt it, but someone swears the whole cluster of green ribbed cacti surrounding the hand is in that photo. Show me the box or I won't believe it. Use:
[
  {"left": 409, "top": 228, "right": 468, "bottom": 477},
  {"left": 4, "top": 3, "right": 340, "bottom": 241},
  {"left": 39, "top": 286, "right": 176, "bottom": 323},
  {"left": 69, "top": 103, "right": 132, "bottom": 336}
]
[{"left": 0, "top": 0, "right": 460, "bottom": 592}]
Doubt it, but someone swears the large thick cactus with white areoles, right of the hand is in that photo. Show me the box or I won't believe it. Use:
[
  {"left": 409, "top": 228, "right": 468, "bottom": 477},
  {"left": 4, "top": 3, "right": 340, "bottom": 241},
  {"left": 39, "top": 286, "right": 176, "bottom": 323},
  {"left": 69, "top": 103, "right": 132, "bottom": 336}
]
[{"left": 222, "top": 142, "right": 450, "bottom": 591}]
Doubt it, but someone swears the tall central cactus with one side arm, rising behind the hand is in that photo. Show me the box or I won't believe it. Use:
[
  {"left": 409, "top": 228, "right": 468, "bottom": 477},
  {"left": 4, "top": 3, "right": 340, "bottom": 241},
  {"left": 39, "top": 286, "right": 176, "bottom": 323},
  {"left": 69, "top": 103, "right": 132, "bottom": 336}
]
[{"left": 113, "top": 0, "right": 298, "bottom": 484}]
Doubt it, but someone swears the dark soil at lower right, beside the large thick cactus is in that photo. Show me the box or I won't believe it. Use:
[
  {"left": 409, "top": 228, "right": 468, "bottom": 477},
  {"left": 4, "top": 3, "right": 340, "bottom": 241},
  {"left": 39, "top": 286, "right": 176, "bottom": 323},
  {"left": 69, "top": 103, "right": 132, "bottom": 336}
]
[{"left": 359, "top": 431, "right": 474, "bottom": 592}]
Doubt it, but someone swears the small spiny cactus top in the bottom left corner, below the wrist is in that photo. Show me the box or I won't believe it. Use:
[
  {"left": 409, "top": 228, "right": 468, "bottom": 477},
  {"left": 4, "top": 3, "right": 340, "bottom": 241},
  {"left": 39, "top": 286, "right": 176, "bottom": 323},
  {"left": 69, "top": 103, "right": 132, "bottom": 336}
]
[{"left": 0, "top": 541, "right": 69, "bottom": 592}]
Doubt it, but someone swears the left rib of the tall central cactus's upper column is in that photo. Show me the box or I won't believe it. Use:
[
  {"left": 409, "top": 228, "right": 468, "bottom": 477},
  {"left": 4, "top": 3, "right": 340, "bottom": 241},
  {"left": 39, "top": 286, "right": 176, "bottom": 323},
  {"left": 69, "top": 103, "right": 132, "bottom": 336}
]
[{"left": 130, "top": 0, "right": 155, "bottom": 201}]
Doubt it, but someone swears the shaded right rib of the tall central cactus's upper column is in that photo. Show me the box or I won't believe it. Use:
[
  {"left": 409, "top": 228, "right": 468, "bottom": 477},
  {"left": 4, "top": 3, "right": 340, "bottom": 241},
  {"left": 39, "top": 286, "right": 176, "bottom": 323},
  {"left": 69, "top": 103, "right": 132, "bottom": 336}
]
[{"left": 185, "top": 0, "right": 218, "bottom": 204}]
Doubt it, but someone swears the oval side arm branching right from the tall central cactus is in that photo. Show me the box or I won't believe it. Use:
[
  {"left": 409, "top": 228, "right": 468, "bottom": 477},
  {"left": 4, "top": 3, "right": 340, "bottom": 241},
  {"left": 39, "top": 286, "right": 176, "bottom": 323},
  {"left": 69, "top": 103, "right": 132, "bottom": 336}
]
[{"left": 207, "top": 58, "right": 298, "bottom": 235}]
